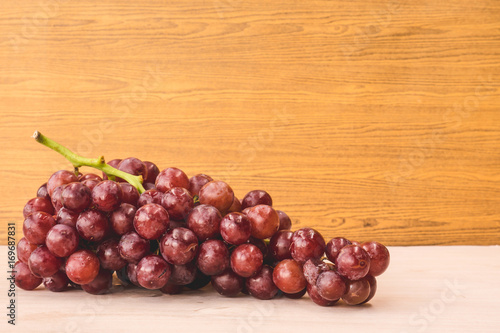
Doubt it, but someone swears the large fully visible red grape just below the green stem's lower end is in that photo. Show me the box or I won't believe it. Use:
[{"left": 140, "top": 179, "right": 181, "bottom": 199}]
[{"left": 134, "top": 204, "right": 170, "bottom": 240}]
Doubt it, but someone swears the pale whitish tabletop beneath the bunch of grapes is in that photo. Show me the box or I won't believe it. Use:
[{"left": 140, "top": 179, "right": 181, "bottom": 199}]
[{"left": 0, "top": 246, "right": 500, "bottom": 333}]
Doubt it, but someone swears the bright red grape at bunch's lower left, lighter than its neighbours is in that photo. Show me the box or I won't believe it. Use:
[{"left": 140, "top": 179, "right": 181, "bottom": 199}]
[{"left": 65, "top": 250, "right": 99, "bottom": 284}]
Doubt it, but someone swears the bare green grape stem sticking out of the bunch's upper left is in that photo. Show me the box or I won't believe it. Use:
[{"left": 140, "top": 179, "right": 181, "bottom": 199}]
[{"left": 33, "top": 131, "right": 146, "bottom": 193}]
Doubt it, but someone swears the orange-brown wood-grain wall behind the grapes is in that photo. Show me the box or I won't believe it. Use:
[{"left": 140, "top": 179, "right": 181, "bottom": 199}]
[{"left": 0, "top": 0, "right": 500, "bottom": 245}]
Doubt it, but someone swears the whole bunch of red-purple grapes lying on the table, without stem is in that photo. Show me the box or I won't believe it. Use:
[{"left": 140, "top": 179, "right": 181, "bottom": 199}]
[{"left": 15, "top": 158, "right": 389, "bottom": 306}]
